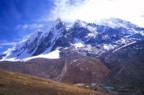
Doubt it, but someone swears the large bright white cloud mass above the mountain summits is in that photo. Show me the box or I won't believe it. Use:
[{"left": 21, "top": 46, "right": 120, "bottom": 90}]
[{"left": 44, "top": 0, "right": 144, "bottom": 26}]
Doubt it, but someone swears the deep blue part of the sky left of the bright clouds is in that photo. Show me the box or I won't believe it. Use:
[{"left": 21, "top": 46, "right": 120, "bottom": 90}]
[{"left": 0, "top": 0, "right": 54, "bottom": 53}]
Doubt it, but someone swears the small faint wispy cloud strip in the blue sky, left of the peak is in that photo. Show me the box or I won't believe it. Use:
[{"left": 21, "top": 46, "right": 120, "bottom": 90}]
[{"left": 16, "top": 24, "right": 44, "bottom": 30}]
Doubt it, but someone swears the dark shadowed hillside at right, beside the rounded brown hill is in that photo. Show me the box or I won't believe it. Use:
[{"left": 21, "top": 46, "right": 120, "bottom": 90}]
[{"left": 100, "top": 41, "right": 144, "bottom": 95}]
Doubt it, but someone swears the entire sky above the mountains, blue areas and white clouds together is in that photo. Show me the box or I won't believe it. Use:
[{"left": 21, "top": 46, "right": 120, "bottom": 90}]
[{"left": 0, "top": 0, "right": 144, "bottom": 54}]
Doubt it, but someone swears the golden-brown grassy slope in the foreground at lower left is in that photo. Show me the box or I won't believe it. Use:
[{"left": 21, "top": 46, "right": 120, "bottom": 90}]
[{"left": 0, "top": 69, "right": 105, "bottom": 95}]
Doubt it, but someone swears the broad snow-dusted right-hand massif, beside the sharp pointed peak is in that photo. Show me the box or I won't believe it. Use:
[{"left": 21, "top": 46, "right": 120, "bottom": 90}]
[{"left": 63, "top": 18, "right": 144, "bottom": 57}]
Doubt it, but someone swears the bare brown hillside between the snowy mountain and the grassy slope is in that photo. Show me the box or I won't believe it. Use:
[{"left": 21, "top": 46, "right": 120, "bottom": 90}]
[{"left": 0, "top": 57, "right": 110, "bottom": 84}]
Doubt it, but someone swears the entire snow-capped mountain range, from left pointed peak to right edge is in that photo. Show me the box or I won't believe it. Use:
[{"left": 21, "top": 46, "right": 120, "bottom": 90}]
[{"left": 3, "top": 18, "right": 144, "bottom": 59}]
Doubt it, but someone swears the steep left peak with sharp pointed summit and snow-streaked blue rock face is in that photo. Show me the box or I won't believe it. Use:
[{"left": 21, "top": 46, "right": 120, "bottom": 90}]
[{"left": 2, "top": 19, "right": 69, "bottom": 59}]
